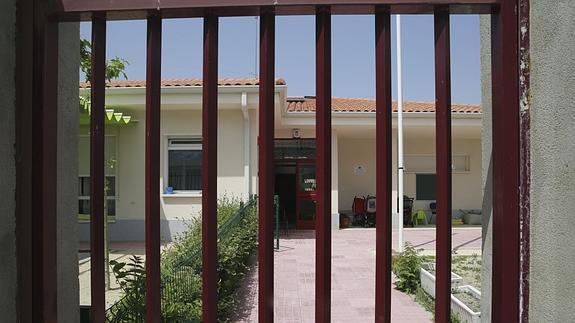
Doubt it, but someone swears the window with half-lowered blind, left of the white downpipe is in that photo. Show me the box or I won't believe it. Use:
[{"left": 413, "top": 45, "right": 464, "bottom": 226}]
[{"left": 166, "top": 138, "right": 202, "bottom": 191}]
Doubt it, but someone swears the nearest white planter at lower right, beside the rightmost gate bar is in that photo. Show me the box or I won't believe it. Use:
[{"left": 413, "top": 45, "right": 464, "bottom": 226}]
[{"left": 451, "top": 285, "right": 481, "bottom": 323}]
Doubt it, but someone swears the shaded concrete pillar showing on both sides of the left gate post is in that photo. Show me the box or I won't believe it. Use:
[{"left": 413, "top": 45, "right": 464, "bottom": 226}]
[{"left": 0, "top": 5, "right": 79, "bottom": 323}]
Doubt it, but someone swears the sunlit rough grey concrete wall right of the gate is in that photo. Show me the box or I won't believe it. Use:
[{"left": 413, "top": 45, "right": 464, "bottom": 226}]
[{"left": 529, "top": 0, "right": 575, "bottom": 322}]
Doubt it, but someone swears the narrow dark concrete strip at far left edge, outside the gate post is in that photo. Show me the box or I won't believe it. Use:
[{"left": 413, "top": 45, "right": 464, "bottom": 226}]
[{"left": 0, "top": 0, "right": 17, "bottom": 323}]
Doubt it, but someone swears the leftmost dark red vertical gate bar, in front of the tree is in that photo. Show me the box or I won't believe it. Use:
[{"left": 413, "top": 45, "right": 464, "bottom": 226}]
[{"left": 90, "top": 13, "right": 106, "bottom": 323}]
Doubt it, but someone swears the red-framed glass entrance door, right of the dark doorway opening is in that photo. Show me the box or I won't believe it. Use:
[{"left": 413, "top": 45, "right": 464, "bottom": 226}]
[{"left": 296, "top": 163, "right": 317, "bottom": 229}]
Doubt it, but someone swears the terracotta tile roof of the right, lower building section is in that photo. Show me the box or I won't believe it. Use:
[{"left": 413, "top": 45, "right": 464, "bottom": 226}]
[{"left": 287, "top": 97, "right": 481, "bottom": 114}]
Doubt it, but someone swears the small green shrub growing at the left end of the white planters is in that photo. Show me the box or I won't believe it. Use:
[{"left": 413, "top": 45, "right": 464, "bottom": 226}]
[{"left": 392, "top": 242, "right": 422, "bottom": 294}]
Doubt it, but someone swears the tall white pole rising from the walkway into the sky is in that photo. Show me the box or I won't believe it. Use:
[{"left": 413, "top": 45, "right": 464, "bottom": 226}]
[{"left": 395, "top": 15, "right": 403, "bottom": 252}]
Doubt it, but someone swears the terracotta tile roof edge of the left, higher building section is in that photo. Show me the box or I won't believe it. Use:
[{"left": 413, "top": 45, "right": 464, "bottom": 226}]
[{"left": 80, "top": 78, "right": 286, "bottom": 89}]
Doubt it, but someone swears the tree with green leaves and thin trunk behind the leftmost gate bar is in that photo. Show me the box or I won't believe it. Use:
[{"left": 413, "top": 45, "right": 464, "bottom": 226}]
[{"left": 80, "top": 39, "right": 129, "bottom": 288}]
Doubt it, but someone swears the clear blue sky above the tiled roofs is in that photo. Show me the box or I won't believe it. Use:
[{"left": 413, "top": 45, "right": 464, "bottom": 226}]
[{"left": 81, "top": 15, "right": 481, "bottom": 103}]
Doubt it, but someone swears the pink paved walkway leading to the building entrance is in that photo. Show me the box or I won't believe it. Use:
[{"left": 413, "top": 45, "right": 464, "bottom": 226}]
[{"left": 234, "top": 228, "right": 481, "bottom": 323}]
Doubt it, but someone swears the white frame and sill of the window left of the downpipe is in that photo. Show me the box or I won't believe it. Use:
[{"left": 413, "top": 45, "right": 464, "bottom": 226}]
[{"left": 165, "top": 134, "right": 203, "bottom": 197}]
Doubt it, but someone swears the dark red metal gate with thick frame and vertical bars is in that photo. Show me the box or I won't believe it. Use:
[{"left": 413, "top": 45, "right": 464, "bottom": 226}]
[{"left": 16, "top": 0, "right": 529, "bottom": 322}]
